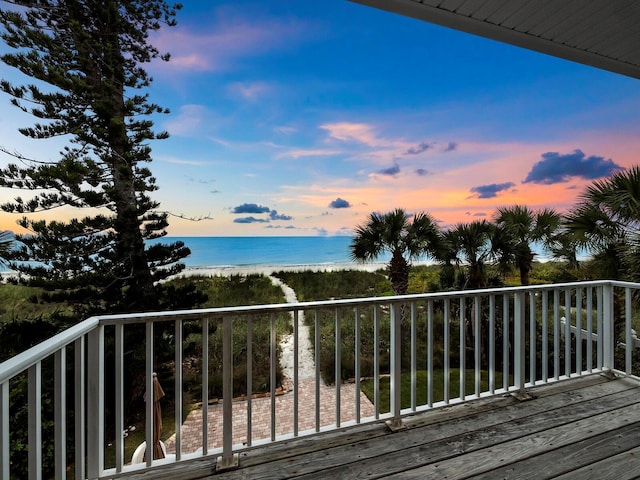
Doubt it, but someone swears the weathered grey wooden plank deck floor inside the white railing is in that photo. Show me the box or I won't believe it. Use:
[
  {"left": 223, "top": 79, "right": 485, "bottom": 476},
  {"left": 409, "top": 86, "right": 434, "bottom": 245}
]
[{"left": 127, "top": 375, "right": 640, "bottom": 480}]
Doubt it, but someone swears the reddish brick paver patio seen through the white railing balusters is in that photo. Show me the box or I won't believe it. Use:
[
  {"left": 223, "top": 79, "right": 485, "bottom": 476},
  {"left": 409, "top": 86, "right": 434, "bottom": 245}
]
[{"left": 165, "top": 379, "right": 374, "bottom": 453}]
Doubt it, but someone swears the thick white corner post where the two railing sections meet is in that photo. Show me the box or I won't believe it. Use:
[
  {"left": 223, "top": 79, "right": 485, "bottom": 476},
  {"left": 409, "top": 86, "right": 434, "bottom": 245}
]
[{"left": 87, "top": 325, "right": 104, "bottom": 480}]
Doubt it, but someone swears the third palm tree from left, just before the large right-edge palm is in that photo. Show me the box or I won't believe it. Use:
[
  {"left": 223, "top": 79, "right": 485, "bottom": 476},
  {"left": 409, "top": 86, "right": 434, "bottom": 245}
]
[{"left": 495, "top": 205, "right": 561, "bottom": 285}]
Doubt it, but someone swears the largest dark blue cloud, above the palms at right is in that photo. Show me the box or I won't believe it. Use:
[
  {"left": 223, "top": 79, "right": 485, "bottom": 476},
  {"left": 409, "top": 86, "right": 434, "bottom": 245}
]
[{"left": 522, "top": 149, "right": 622, "bottom": 185}]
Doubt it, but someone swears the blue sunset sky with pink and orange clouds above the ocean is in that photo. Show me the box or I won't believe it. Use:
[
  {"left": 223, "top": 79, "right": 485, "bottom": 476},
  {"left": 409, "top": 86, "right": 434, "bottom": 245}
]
[{"left": 0, "top": 0, "right": 640, "bottom": 236}]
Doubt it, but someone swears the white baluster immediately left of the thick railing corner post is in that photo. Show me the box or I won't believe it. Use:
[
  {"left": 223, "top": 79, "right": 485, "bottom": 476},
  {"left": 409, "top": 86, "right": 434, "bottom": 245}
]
[{"left": 73, "top": 336, "right": 87, "bottom": 478}]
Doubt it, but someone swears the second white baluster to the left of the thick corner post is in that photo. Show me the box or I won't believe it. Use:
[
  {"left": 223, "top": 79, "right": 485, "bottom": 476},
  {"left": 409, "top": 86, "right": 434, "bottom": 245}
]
[{"left": 53, "top": 347, "right": 67, "bottom": 480}]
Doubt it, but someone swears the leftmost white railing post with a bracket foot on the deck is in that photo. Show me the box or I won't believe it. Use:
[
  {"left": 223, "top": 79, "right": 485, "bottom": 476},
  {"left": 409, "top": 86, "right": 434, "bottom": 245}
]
[{"left": 216, "top": 315, "right": 238, "bottom": 471}]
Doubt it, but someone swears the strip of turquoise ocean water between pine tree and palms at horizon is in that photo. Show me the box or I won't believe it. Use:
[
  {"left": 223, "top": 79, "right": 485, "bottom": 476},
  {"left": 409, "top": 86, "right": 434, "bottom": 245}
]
[{"left": 152, "top": 236, "right": 378, "bottom": 268}]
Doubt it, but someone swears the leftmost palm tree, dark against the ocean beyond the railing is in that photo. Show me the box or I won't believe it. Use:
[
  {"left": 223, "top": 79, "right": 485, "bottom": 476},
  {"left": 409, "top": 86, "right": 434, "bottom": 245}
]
[{"left": 350, "top": 208, "right": 439, "bottom": 295}]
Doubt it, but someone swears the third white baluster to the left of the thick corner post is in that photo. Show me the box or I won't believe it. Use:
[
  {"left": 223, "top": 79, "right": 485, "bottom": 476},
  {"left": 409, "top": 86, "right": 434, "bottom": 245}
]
[{"left": 28, "top": 362, "right": 42, "bottom": 480}]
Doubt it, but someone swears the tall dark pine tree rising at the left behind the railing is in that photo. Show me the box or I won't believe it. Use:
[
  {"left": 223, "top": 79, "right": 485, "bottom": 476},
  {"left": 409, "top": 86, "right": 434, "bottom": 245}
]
[{"left": 0, "top": 0, "right": 190, "bottom": 313}]
